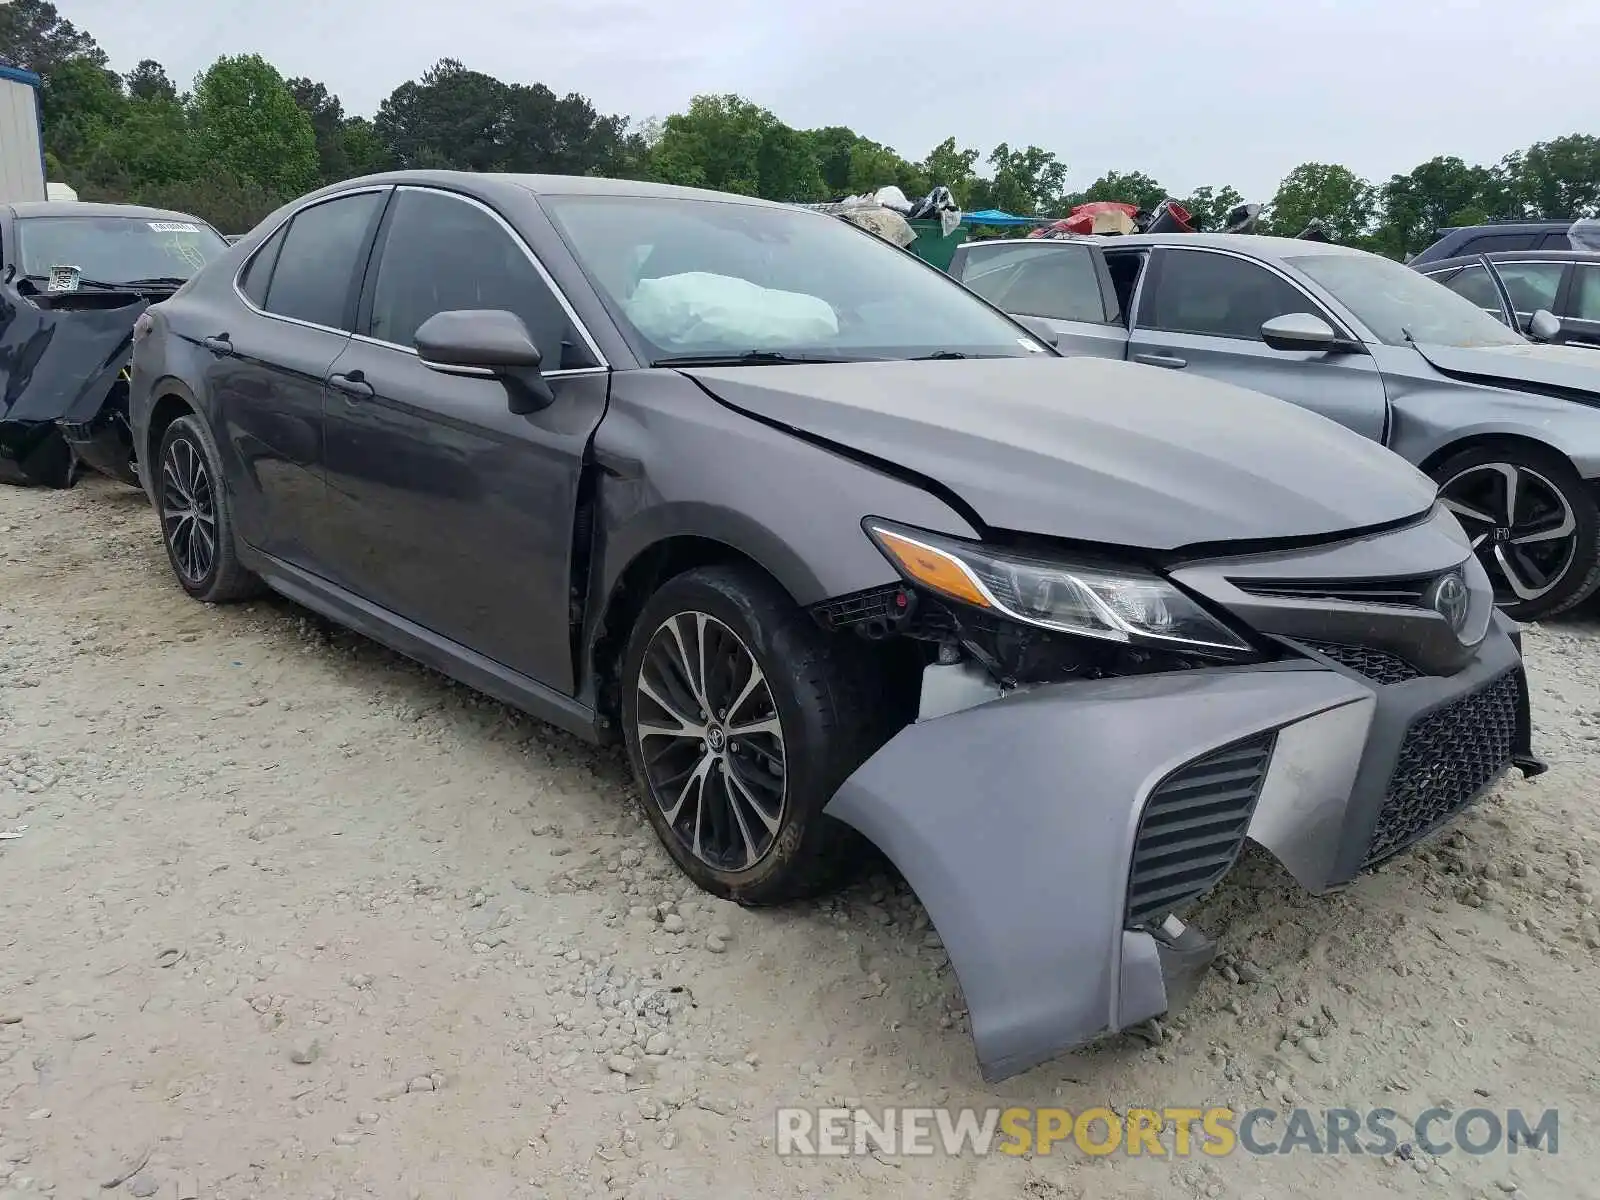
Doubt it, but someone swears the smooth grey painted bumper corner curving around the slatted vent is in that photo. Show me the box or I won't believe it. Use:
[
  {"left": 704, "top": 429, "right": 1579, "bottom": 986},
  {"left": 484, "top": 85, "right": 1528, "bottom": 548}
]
[{"left": 824, "top": 667, "right": 1371, "bottom": 1080}]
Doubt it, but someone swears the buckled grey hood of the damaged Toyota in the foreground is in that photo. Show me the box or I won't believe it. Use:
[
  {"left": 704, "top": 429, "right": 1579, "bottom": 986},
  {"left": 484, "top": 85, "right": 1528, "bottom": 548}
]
[{"left": 685, "top": 357, "right": 1435, "bottom": 550}]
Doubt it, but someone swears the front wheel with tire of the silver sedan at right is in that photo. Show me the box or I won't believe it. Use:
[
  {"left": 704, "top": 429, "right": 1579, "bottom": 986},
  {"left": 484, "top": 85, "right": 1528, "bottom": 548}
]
[{"left": 1434, "top": 445, "right": 1600, "bottom": 621}]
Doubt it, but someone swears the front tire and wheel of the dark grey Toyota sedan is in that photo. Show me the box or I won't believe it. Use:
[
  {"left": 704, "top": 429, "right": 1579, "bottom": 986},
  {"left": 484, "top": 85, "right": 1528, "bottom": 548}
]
[{"left": 622, "top": 566, "right": 886, "bottom": 904}]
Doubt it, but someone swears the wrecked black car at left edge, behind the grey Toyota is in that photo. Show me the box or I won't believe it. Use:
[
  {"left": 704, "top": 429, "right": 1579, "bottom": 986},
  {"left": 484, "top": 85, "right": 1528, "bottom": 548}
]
[{"left": 0, "top": 200, "right": 227, "bottom": 488}]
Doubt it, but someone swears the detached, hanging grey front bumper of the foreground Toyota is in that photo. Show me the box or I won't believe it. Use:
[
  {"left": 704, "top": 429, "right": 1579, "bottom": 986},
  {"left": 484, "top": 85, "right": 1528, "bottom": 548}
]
[{"left": 826, "top": 613, "right": 1536, "bottom": 1080}]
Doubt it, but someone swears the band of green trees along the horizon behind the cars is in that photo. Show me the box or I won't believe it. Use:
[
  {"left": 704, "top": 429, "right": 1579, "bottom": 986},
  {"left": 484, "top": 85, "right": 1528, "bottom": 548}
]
[{"left": 0, "top": 0, "right": 1600, "bottom": 258}]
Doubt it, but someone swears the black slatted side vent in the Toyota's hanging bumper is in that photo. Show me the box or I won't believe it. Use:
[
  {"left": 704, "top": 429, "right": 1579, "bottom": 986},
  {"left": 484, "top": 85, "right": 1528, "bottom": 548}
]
[{"left": 1126, "top": 733, "right": 1277, "bottom": 928}]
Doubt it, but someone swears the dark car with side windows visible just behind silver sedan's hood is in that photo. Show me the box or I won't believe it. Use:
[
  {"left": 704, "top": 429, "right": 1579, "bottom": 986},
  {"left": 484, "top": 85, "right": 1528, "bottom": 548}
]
[{"left": 1413, "top": 250, "right": 1600, "bottom": 347}]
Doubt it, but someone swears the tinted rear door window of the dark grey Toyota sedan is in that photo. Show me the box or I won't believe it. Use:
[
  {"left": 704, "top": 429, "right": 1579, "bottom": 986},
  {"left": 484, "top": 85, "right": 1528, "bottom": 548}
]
[{"left": 262, "top": 192, "right": 387, "bottom": 330}]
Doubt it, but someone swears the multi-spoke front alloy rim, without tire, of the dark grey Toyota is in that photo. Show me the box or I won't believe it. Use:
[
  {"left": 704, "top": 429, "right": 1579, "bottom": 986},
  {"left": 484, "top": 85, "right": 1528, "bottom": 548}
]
[{"left": 635, "top": 611, "right": 787, "bottom": 872}]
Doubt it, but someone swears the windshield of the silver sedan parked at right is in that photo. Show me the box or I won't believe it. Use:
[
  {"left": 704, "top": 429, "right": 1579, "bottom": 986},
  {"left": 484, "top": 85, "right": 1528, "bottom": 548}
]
[{"left": 1285, "top": 254, "right": 1525, "bottom": 346}]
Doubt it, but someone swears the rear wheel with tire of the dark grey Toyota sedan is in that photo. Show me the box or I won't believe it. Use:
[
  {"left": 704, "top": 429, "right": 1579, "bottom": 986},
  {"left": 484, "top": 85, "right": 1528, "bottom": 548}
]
[{"left": 154, "top": 414, "right": 261, "bottom": 605}]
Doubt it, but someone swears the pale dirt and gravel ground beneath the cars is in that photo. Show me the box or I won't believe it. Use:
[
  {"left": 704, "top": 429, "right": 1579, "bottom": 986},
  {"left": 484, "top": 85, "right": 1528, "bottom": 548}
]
[{"left": 0, "top": 482, "right": 1600, "bottom": 1200}]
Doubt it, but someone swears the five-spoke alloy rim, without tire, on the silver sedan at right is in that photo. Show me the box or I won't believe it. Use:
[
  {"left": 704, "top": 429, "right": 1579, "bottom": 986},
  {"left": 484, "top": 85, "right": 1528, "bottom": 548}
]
[{"left": 1440, "top": 462, "right": 1578, "bottom": 605}]
